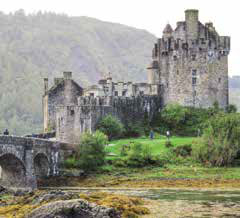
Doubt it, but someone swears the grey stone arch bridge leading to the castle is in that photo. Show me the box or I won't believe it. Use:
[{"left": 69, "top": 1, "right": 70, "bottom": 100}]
[{"left": 0, "top": 136, "right": 73, "bottom": 189}]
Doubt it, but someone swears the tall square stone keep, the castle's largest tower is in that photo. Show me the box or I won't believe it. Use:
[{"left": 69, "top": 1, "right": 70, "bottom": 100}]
[{"left": 147, "top": 9, "right": 230, "bottom": 108}]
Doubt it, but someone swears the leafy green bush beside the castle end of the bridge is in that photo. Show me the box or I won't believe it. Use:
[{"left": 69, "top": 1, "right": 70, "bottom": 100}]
[{"left": 77, "top": 131, "right": 108, "bottom": 171}]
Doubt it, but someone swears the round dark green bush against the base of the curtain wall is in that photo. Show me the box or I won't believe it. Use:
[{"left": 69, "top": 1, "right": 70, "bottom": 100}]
[{"left": 97, "top": 115, "right": 124, "bottom": 140}]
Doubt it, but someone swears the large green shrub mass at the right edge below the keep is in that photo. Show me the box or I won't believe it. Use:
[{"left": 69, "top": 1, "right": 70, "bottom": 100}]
[{"left": 193, "top": 114, "right": 240, "bottom": 166}]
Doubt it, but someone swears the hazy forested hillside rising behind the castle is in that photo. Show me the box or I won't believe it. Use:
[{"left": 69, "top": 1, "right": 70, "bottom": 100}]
[{"left": 0, "top": 10, "right": 156, "bottom": 134}]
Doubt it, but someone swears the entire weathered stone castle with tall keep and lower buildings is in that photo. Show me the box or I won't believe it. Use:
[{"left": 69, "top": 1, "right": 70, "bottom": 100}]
[{"left": 43, "top": 10, "right": 230, "bottom": 143}]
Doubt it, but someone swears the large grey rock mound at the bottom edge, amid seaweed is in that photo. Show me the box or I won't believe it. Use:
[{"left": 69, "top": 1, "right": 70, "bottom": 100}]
[{"left": 26, "top": 199, "right": 121, "bottom": 218}]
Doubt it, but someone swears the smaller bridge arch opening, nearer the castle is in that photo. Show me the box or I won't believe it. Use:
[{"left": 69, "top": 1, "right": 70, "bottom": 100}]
[{"left": 33, "top": 153, "right": 50, "bottom": 179}]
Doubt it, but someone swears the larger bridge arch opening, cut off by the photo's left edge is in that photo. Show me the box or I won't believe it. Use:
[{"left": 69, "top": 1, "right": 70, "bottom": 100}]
[{"left": 0, "top": 153, "right": 26, "bottom": 187}]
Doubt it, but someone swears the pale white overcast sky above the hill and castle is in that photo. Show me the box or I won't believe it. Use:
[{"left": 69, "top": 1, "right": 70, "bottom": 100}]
[{"left": 0, "top": 0, "right": 240, "bottom": 75}]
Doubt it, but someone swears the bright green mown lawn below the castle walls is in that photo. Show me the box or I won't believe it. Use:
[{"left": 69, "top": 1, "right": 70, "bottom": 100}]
[{"left": 106, "top": 135, "right": 196, "bottom": 156}]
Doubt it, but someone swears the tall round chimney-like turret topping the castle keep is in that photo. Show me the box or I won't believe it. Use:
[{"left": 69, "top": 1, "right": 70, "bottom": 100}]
[{"left": 185, "top": 9, "right": 198, "bottom": 40}]
